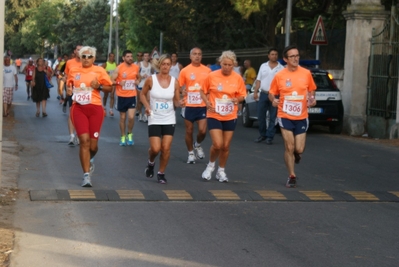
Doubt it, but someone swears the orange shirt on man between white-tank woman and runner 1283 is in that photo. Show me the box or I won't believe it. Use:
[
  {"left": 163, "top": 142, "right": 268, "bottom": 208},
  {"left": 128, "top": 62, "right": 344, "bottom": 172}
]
[{"left": 179, "top": 64, "right": 211, "bottom": 107}]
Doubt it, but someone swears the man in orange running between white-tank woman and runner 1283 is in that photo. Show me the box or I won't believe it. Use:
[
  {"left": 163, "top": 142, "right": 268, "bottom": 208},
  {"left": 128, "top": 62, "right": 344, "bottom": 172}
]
[{"left": 179, "top": 47, "right": 211, "bottom": 164}]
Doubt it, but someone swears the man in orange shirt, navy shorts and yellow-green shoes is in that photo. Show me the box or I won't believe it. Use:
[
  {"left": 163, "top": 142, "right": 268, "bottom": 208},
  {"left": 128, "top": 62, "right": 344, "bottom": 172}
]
[{"left": 111, "top": 50, "right": 141, "bottom": 146}]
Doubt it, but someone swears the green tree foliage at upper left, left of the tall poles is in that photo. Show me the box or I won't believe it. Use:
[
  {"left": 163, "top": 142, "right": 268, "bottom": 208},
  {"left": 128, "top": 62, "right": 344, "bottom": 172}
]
[{"left": 5, "top": 0, "right": 109, "bottom": 56}]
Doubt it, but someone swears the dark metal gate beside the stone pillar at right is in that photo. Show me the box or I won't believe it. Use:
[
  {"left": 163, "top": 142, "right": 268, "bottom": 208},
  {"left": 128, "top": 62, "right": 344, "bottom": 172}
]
[{"left": 367, "top": 10, "right": 399, "bottom": 120}]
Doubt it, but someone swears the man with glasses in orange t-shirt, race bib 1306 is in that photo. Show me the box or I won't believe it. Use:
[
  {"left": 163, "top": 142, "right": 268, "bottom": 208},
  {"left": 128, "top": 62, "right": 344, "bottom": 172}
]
[{"left": 269, "top": 45, "right": 317, "bottom": 188}]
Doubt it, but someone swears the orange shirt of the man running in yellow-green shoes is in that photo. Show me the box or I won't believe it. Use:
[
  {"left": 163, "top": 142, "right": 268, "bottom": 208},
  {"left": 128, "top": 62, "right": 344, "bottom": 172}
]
[{"left": 115, "top": 62, "right": 140, "bottom": 97}]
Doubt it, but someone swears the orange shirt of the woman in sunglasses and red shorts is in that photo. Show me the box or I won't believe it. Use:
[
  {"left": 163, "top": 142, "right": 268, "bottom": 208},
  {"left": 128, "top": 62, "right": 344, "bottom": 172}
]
[{"left": 67, "top": 65, "right": 112, "bottom": 106}]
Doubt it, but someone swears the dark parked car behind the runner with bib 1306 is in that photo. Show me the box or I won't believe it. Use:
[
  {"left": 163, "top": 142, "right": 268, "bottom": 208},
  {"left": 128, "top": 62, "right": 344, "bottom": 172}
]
[{"left": 242, "top": 68, "right": 344, "bottom": 134}]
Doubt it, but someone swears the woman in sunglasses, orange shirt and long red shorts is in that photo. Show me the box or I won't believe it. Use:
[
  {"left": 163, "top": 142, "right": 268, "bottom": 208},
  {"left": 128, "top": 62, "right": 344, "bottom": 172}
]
[{"left": 67, "top": 46, "right": 112, "bottom": 187}]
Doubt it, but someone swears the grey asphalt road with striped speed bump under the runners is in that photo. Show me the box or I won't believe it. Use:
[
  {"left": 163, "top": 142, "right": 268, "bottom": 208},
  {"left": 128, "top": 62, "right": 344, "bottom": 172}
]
[{"left": 5, "top": 76, "right": 399, "bottom": 267}]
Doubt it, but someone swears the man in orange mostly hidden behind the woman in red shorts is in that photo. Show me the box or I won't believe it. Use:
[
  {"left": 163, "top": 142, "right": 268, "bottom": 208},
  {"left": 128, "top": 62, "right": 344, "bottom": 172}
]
[{"left": 62, "top": 45, "right": 82, "bottom": 146}]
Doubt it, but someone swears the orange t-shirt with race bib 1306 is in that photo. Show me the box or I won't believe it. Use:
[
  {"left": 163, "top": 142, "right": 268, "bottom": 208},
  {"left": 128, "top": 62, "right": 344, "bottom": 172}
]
[{"left": 269, "top": 66, "right": 317, "bottom": 120}]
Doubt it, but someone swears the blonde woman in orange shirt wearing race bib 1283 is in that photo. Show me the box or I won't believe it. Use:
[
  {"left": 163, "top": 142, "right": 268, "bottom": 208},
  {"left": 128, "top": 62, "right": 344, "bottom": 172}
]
[{"left": 201, "top": 51, "right": 247, "bottom": 183}]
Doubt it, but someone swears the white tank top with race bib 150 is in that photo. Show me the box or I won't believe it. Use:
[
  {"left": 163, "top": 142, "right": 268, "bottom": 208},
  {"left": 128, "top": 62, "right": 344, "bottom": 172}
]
[{"left": 148, "top": 74, "right": 176, "bottom": 125}]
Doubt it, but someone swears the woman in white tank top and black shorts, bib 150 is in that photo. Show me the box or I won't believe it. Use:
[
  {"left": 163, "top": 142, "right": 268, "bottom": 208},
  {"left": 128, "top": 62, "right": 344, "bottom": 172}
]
[{"left": 140, "top": 55, "right": 180, "bottom": 184}]
